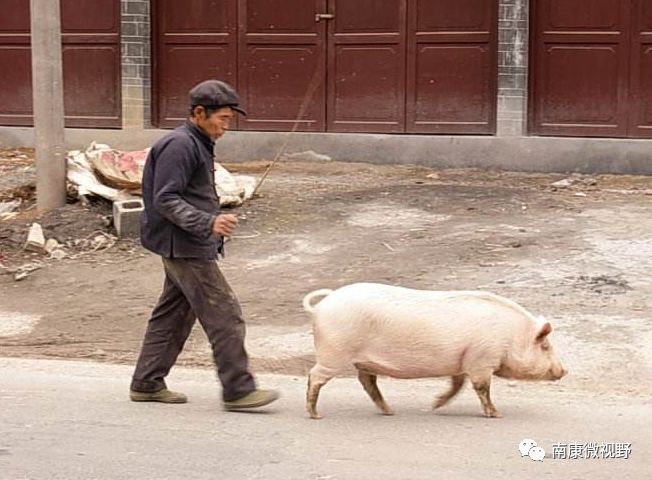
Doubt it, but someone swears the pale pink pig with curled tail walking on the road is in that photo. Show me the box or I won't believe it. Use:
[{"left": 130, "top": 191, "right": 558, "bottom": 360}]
[{"left": 303, "top": 283, "right": 567, "bottom": 419}]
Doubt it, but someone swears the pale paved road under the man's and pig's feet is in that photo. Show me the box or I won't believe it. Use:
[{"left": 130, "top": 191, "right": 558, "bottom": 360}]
[{"left": 0, "top": 358, "right": 652, "bottom": 480}]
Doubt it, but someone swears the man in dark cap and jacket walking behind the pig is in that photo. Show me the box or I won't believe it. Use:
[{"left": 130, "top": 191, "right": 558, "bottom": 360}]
[{"left": 130, "top": 80, "right": 278, "bottom": 410}]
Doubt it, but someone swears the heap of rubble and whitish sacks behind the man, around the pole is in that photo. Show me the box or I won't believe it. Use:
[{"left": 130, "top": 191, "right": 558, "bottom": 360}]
[{"left": 0, "top": 142, "right": 256, "bottom": 272}]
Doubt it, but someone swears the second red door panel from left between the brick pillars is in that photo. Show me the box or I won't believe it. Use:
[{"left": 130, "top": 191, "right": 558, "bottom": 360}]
[{"left": 238, "top": 0, "right": 326, "bottom": 131}]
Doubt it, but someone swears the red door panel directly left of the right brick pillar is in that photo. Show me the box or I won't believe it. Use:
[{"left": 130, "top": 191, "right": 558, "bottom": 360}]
[{"left": 406, "top": 0, "right": 498, "bottom": 134}]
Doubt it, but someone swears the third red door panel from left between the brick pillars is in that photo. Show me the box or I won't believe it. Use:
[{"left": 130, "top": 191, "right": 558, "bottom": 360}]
[{"left": 328, "top": 0, "right": 406, "bottom": 133}]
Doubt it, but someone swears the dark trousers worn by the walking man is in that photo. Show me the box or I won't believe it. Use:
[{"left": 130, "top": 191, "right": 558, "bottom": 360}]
[{"left": 131, "top": 258, "right": 256, "bottom": 401}]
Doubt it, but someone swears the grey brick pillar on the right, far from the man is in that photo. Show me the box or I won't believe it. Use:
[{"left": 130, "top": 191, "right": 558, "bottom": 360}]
[{"left": 498, "top": 0, "right": 529, "bottom": 136}]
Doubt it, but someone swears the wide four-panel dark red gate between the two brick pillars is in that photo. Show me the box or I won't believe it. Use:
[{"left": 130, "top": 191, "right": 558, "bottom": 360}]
[{"left": 154, "top": 0, "right": 498, "bottom": 134}]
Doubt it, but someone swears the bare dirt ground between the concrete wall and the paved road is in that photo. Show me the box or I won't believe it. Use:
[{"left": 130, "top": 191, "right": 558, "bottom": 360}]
[{"left": 0, "top": 150, "right": 652, "bottom": 395}]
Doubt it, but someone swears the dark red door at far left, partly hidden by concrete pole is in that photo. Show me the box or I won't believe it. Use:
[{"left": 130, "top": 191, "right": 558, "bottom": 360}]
[{"left": 0, "top": 0, "right": 122, "bottom": 128}]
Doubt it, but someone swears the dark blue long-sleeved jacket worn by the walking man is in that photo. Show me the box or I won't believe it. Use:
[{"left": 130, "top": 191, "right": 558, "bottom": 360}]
[{"left": 140, "top": 121, "right": 223, "bottom": 259}]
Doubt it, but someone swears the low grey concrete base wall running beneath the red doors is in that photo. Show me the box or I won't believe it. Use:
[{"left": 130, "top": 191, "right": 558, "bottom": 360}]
[{"left": 0, "top": 127, "right": 652, "bottom": 175}]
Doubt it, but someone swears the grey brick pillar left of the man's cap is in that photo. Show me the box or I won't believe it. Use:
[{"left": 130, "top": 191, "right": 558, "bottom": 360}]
[{"left": 121, "top": 0, "right": 152, "bottom": 128}]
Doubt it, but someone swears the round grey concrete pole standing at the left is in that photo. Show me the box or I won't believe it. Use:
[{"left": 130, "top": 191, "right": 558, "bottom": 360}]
[{"left": 30, "top": 0, "right": 66, "bottom": 211}]
